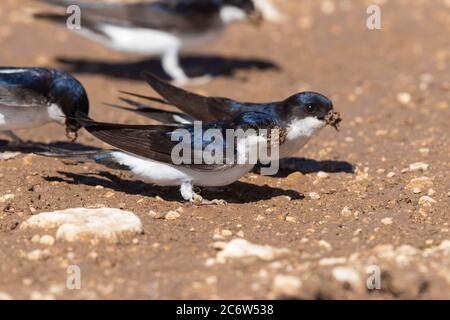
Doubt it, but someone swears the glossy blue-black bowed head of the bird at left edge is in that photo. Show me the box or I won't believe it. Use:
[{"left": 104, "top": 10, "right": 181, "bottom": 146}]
[{"left": 49, "top": 71, "right": 89, "bottom": 133}]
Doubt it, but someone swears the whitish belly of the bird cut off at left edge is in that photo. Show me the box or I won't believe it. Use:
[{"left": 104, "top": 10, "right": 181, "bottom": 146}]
[{"left": 0, "top": 105, "right": 51, "bottom": 131}]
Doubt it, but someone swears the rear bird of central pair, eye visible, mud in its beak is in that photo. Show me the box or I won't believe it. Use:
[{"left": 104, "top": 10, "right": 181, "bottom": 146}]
[{"left": 108, "top": 72, "right": 341, "bottom": 158}]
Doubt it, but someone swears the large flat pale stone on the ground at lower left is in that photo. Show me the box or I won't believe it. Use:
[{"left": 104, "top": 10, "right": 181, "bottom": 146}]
[{"left": 21, "top": 208, "right": 143, "bottom": 243}]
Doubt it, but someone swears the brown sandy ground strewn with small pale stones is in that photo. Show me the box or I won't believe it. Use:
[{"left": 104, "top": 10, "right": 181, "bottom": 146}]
[{"left": 0, "top": 0, "right": 450, "bottom": 299}]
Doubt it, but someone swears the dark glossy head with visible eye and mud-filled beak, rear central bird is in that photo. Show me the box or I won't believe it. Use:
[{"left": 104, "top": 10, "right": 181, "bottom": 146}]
[{"left": 282, "top": 92, "right": 340, "bottom": 126}]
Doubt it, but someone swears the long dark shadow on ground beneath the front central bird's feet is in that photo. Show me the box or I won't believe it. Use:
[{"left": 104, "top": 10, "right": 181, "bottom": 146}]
[{"left": 44, "top": 171, "right": 304, "bottom": 204}]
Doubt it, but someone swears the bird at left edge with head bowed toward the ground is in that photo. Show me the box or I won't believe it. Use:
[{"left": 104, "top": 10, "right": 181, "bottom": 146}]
[{"left": 0, "top": 67, "right": 89, "bottom": 143}]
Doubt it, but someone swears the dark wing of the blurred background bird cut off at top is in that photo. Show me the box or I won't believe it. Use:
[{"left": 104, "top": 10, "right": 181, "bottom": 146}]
[{"left": 35, "top": 0, "right": 221, "bottom": 34}]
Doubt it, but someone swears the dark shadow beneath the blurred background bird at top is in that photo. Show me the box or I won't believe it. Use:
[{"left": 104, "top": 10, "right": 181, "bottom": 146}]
[{"left": 56, "top": 55, "right": 280, "bottom": 81}]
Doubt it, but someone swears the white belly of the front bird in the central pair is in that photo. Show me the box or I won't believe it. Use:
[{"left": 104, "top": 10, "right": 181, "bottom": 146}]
[{"left": 113, "top": 152, "right": 253, "bottom": 187}]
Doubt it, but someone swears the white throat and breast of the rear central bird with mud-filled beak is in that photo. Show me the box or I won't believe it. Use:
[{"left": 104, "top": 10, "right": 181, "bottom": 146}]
[{"left": 280, "top": 117, "right": 326, "bottom": 158}]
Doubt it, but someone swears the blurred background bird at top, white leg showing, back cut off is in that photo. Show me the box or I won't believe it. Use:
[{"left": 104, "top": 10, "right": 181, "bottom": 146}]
[{"left": 35, "top": 0, "right": 261, "bottom": 85}]
